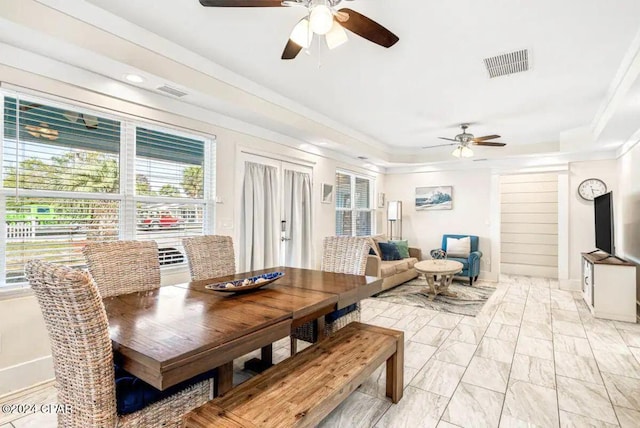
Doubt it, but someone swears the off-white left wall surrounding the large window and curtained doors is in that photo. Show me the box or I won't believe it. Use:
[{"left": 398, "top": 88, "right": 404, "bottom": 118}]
[{"left": 0, "top": 68, "right": 384, "bottom": 395}]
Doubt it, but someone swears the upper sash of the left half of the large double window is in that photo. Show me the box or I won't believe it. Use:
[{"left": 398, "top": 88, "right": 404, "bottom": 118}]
[{"left": 2, "top": 98, "right": 120, "bottom": 193}]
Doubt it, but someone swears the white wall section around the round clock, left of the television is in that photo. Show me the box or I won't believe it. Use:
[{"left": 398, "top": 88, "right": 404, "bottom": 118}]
[{"left": 569, "top": 159, "right": 620, "bottom": 284}]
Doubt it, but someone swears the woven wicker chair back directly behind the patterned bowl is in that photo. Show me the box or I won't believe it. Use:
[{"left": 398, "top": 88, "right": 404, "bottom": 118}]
[{"left": 182, "top": 235, "right": 236, "bottom": 281}]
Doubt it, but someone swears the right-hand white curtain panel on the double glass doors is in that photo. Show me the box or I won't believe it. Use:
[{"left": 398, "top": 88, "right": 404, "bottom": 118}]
[{"left": 284, "top": 170, "right": 311, "bottom": 268}]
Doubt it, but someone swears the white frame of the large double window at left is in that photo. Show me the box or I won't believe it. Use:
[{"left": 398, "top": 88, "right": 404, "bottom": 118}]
[{"left": 0, "top": 88, "right": 217, "bottom": 290}]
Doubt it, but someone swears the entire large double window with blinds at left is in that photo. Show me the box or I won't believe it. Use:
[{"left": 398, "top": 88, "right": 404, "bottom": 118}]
[{"left": 0, "top": 93, "right": 215, "bottom": 286}]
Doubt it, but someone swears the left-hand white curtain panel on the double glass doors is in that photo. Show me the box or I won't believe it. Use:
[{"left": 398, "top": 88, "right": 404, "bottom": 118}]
[{"left": 240, "top": 162, "right": 280, "bottom": 272}]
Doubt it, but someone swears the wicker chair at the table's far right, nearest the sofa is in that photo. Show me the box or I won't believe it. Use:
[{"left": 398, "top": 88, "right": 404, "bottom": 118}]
[{"left": 291, "top": 236, "right": 371, "bottom": 355}]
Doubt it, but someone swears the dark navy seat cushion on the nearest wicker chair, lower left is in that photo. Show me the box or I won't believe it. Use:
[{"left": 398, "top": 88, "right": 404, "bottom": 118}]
[{"left": 114, "top": 363, "right": 215, "bottom": 415}]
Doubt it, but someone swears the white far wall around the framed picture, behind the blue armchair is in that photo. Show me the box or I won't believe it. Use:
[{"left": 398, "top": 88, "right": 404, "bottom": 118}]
[{"left": 385, "top": 169, "right": 499, "bottom": 281}]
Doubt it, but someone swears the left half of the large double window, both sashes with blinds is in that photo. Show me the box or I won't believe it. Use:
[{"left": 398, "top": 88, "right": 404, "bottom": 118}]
[{"left": 2, "top": 97, "right": 120, "bottom": 284}]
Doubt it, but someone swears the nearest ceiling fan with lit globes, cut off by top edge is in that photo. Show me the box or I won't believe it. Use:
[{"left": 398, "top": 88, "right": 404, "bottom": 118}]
[{"left": 200, "top": 0, "right": 400, "bottom": 59}]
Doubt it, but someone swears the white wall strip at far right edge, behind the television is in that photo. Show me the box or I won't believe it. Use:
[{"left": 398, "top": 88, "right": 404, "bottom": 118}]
[{"left": 614, "top": 144, "right": 640, "bottom": 308}]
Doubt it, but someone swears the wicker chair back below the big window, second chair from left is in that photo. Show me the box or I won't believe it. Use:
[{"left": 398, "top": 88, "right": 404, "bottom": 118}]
[{"left": 82, "top": 241, "right": 160, "bottom": 298}]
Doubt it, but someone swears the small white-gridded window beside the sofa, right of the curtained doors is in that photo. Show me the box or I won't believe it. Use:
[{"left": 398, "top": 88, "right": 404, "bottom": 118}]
[{"left": 335, "top": 171, "right": 374, "bottom": 236}]
